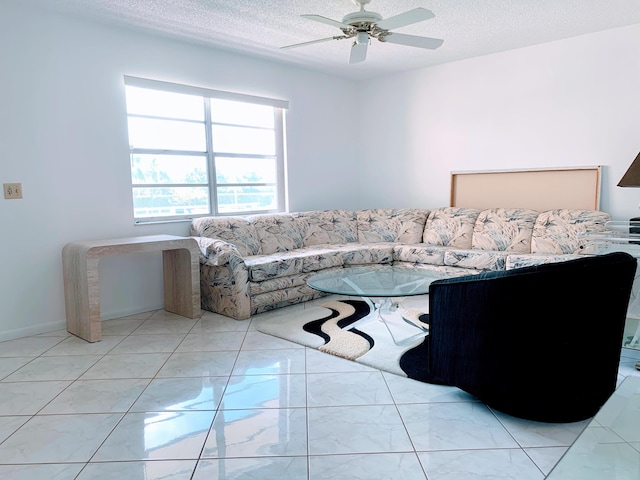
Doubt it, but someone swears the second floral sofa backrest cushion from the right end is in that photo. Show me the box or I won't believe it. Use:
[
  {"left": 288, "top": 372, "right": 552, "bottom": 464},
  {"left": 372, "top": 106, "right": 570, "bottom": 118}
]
[{"left": 471, "top": 208, "right": 539, "bottom": 253}]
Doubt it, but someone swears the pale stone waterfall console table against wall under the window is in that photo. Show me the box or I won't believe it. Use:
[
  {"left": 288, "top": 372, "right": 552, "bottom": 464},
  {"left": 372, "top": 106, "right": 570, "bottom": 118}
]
[{"left": 62, "top": 235, "right": 201, "bottom": 342}]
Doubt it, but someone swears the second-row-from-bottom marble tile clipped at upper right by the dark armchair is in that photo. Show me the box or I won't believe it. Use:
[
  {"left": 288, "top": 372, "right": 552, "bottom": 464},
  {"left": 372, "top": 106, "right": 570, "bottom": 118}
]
[{"left": 398, "top": 402, "right": 518, "bottom": 451}]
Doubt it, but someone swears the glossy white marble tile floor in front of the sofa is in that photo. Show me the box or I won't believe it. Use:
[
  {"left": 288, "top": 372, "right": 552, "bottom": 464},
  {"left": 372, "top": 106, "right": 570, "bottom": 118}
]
[{"left": 0, "top": 305, "right": 640, "bottom": 480}]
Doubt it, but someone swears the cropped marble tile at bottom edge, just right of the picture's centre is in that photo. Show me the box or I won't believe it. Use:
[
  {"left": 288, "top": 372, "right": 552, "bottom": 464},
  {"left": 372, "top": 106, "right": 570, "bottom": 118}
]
[{"left": 309, "top": 453, "right": 428, "bottom": 480}]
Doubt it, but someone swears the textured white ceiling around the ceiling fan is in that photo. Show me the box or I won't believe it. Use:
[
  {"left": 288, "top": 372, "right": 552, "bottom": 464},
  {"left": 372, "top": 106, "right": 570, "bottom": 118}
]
[{"left": 22, "top": 0, "right": 640, "bottom": 79}]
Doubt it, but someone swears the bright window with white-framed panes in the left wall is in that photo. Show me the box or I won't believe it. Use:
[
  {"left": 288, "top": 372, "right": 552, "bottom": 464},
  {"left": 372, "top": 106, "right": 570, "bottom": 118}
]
[{"left": 125, "top": 76, "right": 287, "bottom": 223}]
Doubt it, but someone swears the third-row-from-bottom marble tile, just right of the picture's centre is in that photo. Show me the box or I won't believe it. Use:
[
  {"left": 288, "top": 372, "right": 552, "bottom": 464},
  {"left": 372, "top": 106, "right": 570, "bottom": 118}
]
[{"left": 307, "top": 371, "right": 393, "bottom": 407}]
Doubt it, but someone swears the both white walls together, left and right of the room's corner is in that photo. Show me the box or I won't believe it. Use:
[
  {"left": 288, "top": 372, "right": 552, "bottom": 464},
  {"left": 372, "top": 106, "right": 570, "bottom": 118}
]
[{"left": 0, "top": 2, "right": 640, "bottom": 340}]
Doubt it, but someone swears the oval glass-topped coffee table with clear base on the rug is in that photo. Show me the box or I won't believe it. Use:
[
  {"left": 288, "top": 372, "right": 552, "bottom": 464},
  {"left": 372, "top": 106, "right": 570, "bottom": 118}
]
[{"left": 307, "top": 265, "right": 450, "bottom": 345}]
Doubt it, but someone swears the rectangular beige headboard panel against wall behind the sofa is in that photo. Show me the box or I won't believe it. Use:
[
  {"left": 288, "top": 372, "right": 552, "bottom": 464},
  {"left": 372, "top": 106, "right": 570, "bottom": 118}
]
[{"left": 451, "top": 165, "right": 602, "bottom": 211}]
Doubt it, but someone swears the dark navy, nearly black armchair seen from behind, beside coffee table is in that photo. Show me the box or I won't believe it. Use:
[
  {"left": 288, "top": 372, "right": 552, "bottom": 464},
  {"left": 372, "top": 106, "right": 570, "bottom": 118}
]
[{"left": 402, "top": 253, "right": 636, "bottom": 422}]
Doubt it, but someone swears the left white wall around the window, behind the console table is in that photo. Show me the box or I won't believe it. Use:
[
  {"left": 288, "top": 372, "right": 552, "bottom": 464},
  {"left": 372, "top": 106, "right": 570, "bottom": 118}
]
[{"left": 0, "top": 2, "right": 358, "bottom": 340}]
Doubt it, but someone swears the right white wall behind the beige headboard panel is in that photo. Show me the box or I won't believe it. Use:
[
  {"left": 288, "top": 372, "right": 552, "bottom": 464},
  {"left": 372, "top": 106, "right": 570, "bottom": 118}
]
[{"left": 360, "top": 25, "right": 640, "bottom": 220}]
